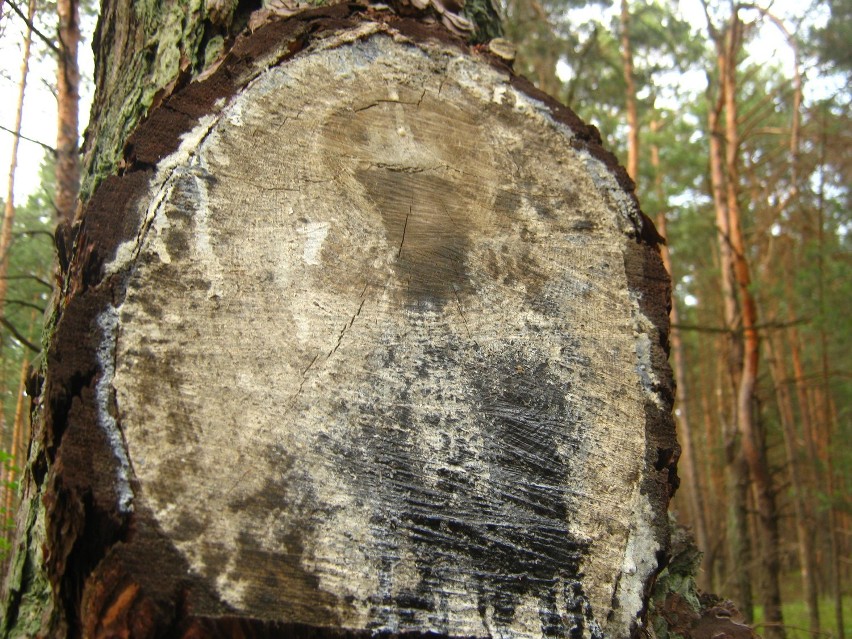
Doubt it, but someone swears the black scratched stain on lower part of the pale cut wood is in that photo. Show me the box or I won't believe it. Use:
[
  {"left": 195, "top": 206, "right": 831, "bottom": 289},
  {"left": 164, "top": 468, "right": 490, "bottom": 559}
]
[{"left": 333, "top": 332, "right": 602, "bottom": 638}]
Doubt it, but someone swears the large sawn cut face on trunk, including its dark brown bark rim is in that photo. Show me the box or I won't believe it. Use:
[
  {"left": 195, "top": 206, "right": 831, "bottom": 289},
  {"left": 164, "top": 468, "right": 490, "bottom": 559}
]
[{"left": 3, "top": 5, "right": 678, "bottom": 637}]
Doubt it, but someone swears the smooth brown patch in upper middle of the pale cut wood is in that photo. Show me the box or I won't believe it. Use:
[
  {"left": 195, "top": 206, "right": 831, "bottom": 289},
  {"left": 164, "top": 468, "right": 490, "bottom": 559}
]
[{"left": 319, "top": 84, "right": 497, "bottom": 312}]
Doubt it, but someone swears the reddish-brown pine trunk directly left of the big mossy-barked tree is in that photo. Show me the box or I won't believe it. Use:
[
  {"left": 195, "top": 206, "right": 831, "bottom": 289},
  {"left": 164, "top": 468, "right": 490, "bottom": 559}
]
[{"left": 55, "top": 0, "right": 80, "bottom": 221}]
